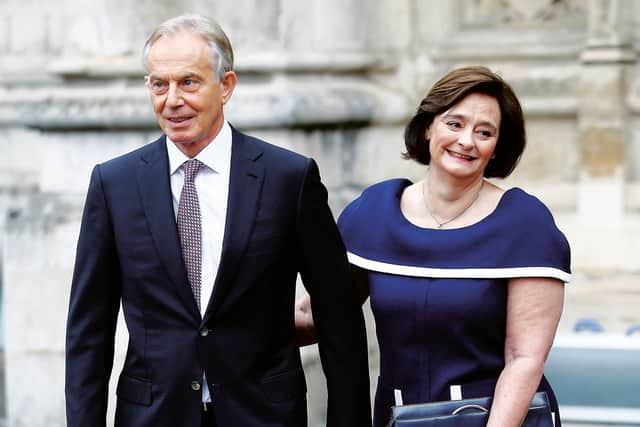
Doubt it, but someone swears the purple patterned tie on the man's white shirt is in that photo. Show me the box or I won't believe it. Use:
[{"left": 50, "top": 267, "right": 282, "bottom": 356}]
[{"left": 178, "top": 159, "right": 203, "bottom": 310}]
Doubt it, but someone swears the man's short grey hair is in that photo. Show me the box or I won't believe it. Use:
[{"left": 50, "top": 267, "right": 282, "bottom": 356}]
[{"left": 142, "top": 15, "right": 233, "bottom": 82}]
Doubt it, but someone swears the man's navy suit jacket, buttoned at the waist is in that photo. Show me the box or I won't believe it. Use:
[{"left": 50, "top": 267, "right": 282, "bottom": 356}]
[{"left": 65, "top": 129, "right": 370, "bottom": 427}]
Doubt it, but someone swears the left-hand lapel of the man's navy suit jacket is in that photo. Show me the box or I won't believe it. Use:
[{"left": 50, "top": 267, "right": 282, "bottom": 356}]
[{"left": 138, "top": 136, "right": 200, "bottom": 319}]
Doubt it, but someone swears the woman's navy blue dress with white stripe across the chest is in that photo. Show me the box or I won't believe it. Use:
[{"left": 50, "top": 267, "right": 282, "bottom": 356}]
[{"left": 338, "top": 179, "right": 571, "bottom": 427}]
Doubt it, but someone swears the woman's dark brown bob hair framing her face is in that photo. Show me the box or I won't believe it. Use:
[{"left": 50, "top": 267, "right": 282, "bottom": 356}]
[{"left": 403, "top": 67, "right": 526, "bottom": 178}]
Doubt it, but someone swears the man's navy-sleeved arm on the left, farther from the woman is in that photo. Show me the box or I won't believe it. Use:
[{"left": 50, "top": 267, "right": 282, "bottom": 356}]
[{"left": 65, "top": 166, "right": 120, "bottom": 427}]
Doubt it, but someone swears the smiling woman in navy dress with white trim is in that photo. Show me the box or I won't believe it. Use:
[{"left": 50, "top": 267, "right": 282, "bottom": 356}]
[{"left": 296, "top": 67, "right": 570, "bottom": 427}]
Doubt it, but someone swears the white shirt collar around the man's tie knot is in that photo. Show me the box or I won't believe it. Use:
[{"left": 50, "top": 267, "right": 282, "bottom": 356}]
[{"left": 166, "top": 120, "right": 231, "bottom": 175}]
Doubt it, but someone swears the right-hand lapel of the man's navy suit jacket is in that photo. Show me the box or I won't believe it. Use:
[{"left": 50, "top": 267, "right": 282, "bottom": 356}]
[{"left": 203, "top": 128, "right": 264, "bottom": 322}]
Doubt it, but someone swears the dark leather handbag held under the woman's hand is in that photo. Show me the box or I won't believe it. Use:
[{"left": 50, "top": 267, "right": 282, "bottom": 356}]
[{"left": 387, "top": 391, "right": 554, "bottom": 427}]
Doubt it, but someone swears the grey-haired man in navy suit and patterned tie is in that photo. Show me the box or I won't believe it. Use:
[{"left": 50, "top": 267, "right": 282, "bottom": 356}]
[{"left": 66, "top": 16, "right": 370, "bottom": 427}]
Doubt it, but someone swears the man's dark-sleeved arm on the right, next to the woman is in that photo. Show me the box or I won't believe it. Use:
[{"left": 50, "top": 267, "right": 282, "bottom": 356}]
[{"left": 297, "top": 161, "right": 371, "bottom": 427}]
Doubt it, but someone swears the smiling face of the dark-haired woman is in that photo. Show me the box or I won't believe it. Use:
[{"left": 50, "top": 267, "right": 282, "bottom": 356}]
[{"left": 426, "top": 93, "right": 501, "bottom": 179}]
